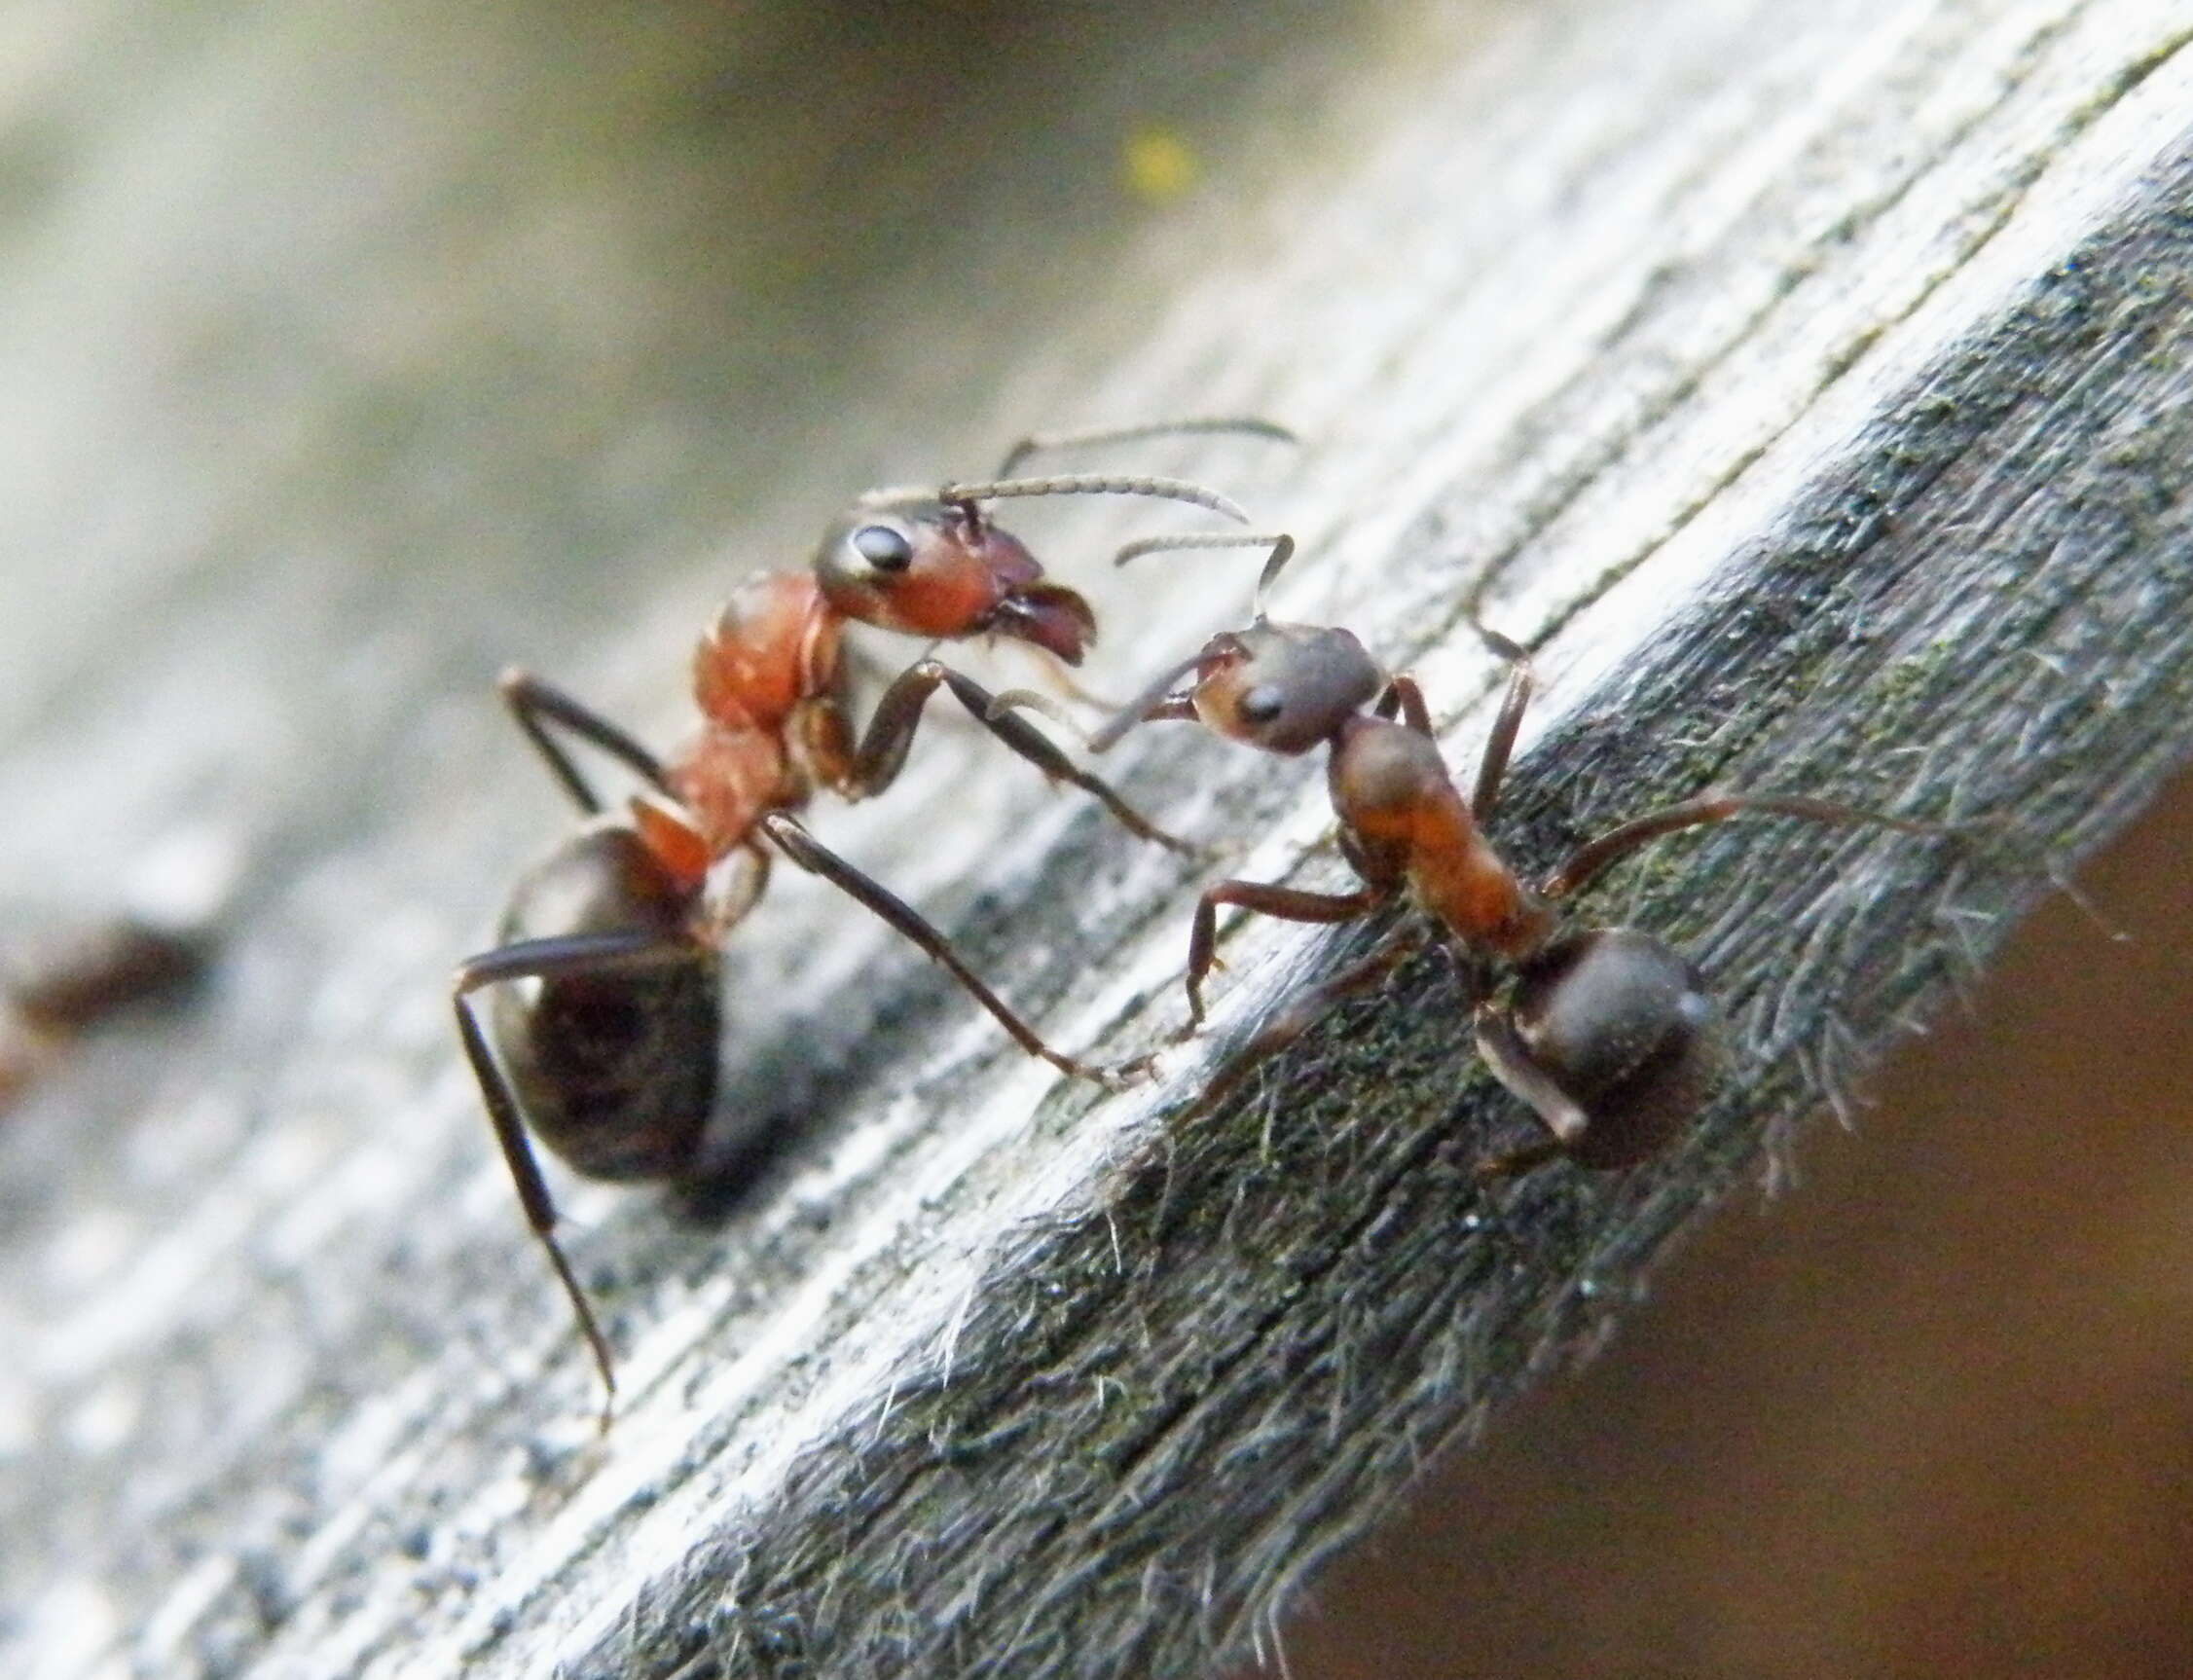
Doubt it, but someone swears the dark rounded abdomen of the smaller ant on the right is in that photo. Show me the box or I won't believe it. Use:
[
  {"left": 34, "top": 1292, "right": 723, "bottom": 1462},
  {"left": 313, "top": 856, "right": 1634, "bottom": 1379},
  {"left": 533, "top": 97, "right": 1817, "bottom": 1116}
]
[{"left": 1476, "top": 928, "right": 1722, "bottom": 1167}]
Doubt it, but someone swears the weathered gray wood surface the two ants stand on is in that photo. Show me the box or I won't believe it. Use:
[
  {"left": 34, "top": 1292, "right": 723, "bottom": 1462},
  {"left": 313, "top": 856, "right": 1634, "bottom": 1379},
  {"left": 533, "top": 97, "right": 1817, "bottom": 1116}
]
[{"left": 0, "top": 0, "right": 2193, "bottom": 1675}]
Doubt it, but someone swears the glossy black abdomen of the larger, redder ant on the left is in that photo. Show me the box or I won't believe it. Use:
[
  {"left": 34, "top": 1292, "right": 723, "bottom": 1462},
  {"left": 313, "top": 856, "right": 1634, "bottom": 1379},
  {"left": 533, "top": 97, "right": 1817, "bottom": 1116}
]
[{"left": 493, "top": 824, "right": 721, "bottom": 1180}]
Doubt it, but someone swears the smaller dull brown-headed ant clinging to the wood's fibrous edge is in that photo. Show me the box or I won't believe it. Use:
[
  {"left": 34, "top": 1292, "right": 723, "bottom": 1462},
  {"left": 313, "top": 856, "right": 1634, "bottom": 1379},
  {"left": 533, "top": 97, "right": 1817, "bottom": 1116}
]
[{"left": 998, "top": 533, "right": 1952, "bottom": 1178}]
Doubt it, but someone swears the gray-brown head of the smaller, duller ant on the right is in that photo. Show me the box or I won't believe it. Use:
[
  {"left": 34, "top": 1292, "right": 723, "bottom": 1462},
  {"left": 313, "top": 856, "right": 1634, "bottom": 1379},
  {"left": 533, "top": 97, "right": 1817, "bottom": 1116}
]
[{"left": 1193, "top": 618, "right": 1386, "bottom": 754}]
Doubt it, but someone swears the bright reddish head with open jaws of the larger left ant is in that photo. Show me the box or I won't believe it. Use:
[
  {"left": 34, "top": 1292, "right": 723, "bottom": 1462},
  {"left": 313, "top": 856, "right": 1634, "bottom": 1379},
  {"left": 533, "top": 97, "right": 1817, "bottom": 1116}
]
[{"left": 816, "top": 492, "right": 1097, "bottom": 665}]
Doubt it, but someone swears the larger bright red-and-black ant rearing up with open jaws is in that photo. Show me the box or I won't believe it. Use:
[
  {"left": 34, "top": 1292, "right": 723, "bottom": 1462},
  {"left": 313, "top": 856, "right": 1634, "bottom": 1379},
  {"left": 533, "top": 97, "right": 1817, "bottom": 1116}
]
[{"left": 452, "top": 419, "right": 1290, "bottom": 1428}]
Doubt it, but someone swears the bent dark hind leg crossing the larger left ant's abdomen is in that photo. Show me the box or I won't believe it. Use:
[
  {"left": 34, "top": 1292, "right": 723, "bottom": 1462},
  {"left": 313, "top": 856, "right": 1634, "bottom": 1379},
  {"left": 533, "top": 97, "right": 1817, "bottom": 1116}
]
[{"left": 450, "top": 930, "right": 691, "bottom": 1430}]
